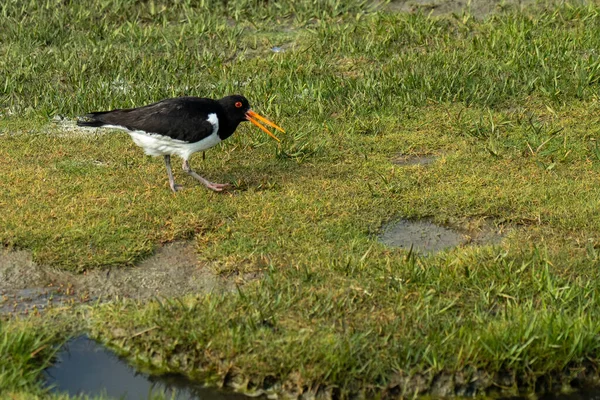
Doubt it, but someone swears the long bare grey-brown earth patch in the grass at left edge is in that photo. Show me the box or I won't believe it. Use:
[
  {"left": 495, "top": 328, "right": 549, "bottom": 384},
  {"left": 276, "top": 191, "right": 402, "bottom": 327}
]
[{"left": 0, "top": 242, "right": 248, "bottom": 315}]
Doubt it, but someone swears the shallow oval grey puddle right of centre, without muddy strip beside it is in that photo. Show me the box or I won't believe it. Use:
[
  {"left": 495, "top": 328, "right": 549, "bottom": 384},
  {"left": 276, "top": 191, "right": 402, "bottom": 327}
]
[{"left": 379, "top": 219, "right": 467, "bottom": 253}]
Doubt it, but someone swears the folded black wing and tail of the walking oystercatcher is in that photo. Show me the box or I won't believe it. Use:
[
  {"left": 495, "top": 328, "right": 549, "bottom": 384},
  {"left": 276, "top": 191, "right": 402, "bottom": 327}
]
[{"left": 80, "top": 97, "right": 220, "bottom": 143}]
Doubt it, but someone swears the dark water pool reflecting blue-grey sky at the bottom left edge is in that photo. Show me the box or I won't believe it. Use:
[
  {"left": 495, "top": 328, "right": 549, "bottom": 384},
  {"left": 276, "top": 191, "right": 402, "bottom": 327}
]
[{"left": 44, "top": 336, "right": 247, "bottom": 400}]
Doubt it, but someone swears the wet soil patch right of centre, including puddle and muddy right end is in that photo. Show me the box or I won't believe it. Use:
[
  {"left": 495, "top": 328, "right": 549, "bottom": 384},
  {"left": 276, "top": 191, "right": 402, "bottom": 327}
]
[{"left": 379, "top": 219, "right": 505, "bottom": 254}]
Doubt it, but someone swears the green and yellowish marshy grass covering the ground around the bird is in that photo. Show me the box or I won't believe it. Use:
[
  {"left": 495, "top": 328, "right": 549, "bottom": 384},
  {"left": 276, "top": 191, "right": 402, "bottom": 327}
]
[{"left": 0, "top": 0, "right": 600, "bottom": 395}]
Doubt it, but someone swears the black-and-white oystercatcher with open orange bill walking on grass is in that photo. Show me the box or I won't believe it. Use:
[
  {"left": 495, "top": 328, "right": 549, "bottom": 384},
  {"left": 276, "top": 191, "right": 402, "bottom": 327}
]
[{"left": 77, "top": 95, "right": 285, "bottom": 192}]
